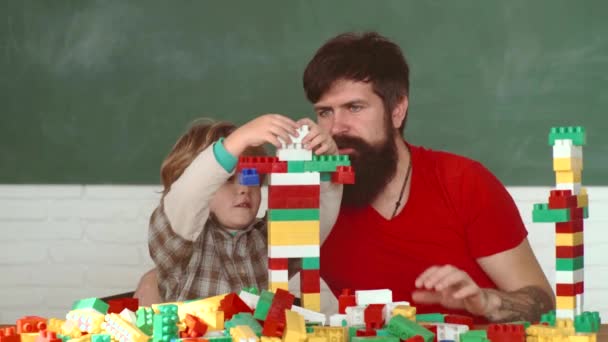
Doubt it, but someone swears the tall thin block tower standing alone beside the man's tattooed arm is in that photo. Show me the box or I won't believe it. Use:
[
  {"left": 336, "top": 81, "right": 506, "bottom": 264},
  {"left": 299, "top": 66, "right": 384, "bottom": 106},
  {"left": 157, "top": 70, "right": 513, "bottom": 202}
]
[{"left": 532, "top": 127, "right": 589, "bottom": 321}]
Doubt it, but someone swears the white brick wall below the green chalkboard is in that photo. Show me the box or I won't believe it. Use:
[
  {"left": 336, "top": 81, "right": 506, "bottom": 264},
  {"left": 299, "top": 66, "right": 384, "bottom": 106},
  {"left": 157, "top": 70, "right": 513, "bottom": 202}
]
[{"left": 0, "top": 185, "right": 608, "bottom": 323}]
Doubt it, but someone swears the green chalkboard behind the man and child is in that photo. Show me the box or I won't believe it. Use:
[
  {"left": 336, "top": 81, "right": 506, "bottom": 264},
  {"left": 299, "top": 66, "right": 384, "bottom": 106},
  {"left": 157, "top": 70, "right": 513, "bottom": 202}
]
[{"left": 0, "top": 0, "right": 608, "bottom": 185}]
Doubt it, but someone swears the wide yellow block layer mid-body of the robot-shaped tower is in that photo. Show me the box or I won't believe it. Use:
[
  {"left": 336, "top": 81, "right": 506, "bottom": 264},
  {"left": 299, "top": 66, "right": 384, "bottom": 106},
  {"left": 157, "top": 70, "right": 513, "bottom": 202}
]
[{"left": 268, "top": 221, "right": 320, "bottom": 246}]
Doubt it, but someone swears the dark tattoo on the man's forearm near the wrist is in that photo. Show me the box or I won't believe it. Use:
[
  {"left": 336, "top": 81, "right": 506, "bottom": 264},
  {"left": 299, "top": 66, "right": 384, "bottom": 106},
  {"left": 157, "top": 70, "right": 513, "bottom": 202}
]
[{"left": 488, "top": 286, "right": 554, "bottom": 322}]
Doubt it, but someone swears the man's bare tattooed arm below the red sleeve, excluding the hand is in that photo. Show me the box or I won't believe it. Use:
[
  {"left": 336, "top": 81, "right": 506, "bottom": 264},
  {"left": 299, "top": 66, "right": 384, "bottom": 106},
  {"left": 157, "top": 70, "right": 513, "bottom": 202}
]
[{"left": 477, "top": 239, "right": 555, "bottom": 322}]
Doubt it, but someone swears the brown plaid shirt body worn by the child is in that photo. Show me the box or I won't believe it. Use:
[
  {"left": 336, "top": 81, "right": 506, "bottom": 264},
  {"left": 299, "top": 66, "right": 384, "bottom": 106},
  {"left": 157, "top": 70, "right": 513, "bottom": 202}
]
[{"left": 148, "top": 199, "right": 268, "bottom": 301}]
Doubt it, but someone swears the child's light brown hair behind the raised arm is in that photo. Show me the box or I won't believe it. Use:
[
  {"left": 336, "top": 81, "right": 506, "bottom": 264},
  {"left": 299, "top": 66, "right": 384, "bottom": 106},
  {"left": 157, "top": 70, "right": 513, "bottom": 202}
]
[{"left": 160, "top": 119, "right": 266, "bottom": 195}]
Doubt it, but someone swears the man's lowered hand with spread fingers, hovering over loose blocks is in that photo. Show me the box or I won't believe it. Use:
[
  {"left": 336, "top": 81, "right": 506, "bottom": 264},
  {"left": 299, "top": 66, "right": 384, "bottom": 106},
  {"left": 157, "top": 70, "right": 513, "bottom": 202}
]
[{"left": 412, "top": 265, "right": 488, "bottom": 316}]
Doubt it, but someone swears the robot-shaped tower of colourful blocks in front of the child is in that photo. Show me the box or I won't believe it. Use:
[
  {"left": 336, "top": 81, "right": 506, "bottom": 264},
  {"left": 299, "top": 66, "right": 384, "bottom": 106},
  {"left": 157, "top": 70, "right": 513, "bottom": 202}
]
[{"left": 237, "top": 125, "right": 355, "bottom": 311}]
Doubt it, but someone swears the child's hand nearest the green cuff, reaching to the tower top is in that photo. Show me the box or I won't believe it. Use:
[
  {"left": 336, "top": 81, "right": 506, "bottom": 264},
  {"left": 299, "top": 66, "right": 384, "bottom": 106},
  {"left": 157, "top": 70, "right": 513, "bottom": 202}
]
[{"left": 224, "top": 114, "right": 298, "bottom": 156}]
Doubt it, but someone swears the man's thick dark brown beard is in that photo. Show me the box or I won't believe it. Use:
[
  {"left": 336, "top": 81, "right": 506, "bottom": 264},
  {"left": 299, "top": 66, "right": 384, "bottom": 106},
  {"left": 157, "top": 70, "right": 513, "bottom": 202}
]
[{"left": 334, "top": 127, "right": 398, "bottom": 207}]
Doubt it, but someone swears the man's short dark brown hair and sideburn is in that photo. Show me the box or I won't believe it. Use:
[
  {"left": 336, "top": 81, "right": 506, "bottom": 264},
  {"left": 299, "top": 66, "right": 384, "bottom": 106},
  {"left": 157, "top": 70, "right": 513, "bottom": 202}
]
[{"left": 303, "top": 32, "right": 410, "bottom": 135}]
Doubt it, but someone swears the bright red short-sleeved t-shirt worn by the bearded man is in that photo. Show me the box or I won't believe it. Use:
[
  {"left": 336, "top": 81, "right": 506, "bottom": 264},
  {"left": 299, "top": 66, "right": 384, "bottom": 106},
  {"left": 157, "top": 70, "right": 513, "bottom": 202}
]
[{"left": 321, "top": 145, "right": 528, "bottom": 320}]
